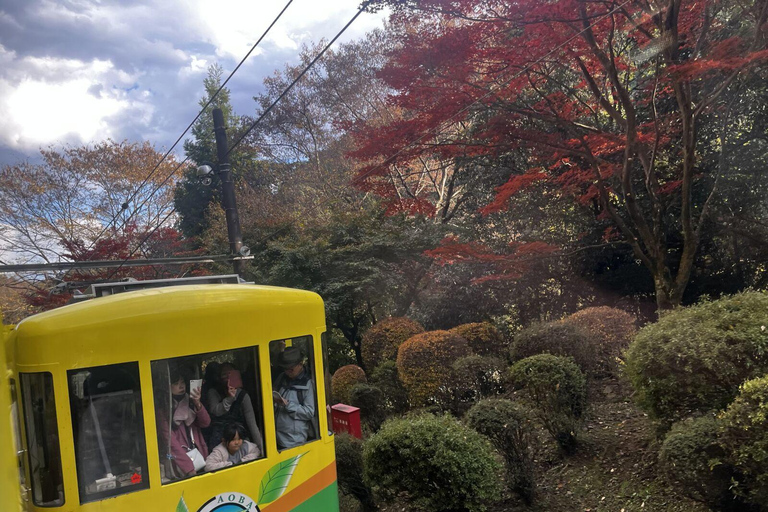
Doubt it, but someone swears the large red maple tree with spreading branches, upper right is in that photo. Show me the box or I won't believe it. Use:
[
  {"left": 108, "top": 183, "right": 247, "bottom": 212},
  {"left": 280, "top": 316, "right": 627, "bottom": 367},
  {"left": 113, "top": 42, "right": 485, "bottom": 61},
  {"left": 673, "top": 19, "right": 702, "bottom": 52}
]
[{"left": 353, "top": 0, "right": 768, "bottom": 308}]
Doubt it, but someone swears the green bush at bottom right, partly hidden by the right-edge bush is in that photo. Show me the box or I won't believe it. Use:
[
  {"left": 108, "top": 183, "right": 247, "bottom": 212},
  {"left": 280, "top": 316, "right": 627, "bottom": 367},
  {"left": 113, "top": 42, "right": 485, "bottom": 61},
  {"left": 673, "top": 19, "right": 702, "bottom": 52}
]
[{"left": 659, "top": 415, "right": 734, "bottom": 510}]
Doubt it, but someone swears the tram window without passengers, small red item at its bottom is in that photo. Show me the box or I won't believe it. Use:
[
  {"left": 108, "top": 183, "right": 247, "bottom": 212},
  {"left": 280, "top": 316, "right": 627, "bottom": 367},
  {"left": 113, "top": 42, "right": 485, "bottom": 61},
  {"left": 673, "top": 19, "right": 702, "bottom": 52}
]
[{"left": 67, "top": 362, "right": 149, "bottom": 503}]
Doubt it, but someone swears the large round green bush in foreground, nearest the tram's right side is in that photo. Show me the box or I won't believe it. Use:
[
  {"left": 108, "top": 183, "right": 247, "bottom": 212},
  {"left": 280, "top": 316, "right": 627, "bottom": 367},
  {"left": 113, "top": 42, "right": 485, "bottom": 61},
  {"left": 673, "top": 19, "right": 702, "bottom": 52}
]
[{"left": 363, "top": 414, "right": 501, "bottom": 511}]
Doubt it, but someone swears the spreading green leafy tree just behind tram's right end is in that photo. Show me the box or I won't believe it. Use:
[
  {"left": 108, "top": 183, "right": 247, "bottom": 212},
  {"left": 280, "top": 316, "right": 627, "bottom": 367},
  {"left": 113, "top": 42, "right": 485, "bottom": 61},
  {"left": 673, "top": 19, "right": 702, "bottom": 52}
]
[{"left": 254, "top": 208, "right": 436, "bottom": 367}]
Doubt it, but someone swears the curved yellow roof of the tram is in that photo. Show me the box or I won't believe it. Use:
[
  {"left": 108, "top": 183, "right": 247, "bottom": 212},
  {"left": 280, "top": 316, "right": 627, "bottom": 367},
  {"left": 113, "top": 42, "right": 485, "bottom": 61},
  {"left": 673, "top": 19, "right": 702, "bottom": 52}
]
[{"left": 16, "top": 284, "right": 323, "bottom": 337}]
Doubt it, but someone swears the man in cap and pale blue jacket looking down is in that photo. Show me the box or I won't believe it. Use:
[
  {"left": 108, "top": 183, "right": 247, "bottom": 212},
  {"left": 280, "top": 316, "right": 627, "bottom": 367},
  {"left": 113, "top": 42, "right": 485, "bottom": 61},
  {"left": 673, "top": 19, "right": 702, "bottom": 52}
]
[{"left": 272, "top": 347, "right": 316, "bottom": 450}]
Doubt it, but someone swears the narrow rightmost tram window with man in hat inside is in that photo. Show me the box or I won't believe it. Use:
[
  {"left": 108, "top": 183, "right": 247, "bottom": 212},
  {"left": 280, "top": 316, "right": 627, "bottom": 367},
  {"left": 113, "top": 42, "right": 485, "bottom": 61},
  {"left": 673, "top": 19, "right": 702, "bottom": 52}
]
[{"left": 269, "top": 336, "right": 320, "bottom": 450}]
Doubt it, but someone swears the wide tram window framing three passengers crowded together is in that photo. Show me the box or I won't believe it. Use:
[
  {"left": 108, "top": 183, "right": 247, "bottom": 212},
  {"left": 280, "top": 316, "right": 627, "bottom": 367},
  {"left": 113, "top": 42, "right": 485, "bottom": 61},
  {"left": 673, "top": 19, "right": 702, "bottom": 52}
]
[{"left": 152, "top": 347, "right": 264, "bottom": 483}]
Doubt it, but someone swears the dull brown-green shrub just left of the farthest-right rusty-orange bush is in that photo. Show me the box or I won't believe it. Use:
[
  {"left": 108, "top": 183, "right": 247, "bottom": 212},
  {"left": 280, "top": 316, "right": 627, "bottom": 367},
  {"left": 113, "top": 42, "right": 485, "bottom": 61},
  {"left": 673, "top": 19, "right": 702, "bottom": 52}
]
[{"left": 510, "top": 322, "right": 597, "bottom": 373}]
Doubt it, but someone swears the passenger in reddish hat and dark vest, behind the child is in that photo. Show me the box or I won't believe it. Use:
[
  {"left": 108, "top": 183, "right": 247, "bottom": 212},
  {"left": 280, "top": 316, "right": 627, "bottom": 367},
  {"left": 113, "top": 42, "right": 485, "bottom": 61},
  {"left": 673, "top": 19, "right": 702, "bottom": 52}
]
[{"left": 206, "top": 363, "right": 264, "bottom": 454}]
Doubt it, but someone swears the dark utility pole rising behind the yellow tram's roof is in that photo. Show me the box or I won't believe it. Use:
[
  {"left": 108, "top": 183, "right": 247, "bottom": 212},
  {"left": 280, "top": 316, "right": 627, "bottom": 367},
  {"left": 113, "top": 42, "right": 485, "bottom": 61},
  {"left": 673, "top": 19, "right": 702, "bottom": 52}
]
[{"left": 213, "top": 108, "right": 244, "bottom": 277}]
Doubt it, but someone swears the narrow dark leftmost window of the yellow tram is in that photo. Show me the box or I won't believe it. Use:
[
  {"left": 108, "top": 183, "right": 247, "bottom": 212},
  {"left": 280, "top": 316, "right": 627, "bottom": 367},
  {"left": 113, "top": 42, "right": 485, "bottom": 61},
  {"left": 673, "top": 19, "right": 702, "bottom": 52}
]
[{"left": 20, "top": 372, "right": 64, "bottom": 507}]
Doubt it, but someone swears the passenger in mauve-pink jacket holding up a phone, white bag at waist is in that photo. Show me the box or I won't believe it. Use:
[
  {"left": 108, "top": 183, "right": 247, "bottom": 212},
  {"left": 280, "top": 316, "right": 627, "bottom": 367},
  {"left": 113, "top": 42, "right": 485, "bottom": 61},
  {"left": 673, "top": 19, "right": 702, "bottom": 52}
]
[{"left": 163, "top": 369, "right": 211, "bottom": 478}]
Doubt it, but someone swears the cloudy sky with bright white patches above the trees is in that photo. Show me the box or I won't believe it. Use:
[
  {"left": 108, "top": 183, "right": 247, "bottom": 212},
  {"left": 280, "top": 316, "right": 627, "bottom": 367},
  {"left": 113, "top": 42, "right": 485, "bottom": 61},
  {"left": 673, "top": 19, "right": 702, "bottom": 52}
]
[{"left": 0, "top": 0, "right": 384, "bottom": 164}]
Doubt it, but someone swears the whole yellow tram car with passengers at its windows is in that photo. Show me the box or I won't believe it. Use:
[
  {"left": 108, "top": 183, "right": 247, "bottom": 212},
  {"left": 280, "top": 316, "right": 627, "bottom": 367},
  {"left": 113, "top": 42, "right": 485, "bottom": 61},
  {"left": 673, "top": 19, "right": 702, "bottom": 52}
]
[{"left": 0, "top": 283, "right": 339, "bottom": 512}]
